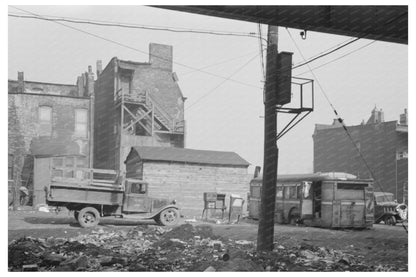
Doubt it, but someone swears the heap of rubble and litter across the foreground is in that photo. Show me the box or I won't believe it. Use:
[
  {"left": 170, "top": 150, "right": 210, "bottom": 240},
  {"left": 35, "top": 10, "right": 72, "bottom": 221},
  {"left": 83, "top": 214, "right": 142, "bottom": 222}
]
[{"left": 8, "top": 224, "right": 407, "bottom": 271}]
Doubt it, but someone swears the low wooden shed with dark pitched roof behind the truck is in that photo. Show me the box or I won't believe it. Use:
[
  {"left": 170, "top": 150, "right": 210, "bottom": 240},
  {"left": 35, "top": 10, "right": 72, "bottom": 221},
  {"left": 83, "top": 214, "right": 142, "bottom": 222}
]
[{"left": 126, "top": 146, "right": 252, "bottom": 216}]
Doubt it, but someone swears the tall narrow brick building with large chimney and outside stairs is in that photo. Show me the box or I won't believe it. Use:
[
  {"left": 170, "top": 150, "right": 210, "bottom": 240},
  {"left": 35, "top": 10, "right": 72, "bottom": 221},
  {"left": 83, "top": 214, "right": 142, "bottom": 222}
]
[{"left": 94, "top": 43, "right": 185, "bottom": 170}]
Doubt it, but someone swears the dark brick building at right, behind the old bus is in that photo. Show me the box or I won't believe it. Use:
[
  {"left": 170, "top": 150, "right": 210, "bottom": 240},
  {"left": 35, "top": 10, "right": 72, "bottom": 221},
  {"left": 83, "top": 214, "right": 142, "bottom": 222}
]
[{"left": 313, "top": 108, "right": 408, "bottom": 202}]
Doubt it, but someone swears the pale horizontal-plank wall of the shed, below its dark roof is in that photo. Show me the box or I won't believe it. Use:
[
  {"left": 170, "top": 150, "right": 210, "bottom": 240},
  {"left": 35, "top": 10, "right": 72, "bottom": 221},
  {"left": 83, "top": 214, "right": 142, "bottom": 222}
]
[{"left": 143, "top": 161, "right": 252, "bottom": 217}]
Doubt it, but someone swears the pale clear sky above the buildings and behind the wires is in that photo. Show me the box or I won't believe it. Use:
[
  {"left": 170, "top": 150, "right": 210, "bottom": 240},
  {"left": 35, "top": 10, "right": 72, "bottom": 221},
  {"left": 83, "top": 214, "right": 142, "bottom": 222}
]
[{"left": 7, "top": 3, "right": 409, "bottom": 174}]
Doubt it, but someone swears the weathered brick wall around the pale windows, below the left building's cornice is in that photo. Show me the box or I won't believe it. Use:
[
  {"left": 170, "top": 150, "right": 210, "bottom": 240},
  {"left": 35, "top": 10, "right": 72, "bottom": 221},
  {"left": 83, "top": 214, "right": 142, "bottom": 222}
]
[{"left": 8, "top": 93, "right": 91, "bottom": 204}]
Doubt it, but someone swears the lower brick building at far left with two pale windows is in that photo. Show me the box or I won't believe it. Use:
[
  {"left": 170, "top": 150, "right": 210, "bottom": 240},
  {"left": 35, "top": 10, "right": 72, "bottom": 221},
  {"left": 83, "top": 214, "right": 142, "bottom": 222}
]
[{"left": 8, "top": 68, "right": 93, "bottom": 204}]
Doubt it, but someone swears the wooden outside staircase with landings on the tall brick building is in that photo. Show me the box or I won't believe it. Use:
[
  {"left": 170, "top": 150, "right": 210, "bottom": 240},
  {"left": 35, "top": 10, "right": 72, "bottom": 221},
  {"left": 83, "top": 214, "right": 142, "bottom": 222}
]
[{"left": 116, "top": 89, "right": 185, "bottom": 136}]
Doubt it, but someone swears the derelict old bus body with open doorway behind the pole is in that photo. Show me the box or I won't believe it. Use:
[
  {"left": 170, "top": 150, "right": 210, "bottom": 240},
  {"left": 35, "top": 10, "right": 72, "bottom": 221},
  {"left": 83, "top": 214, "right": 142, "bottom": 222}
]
[{"left": 248, "top": 173, "right": 374, "bottom": 228}]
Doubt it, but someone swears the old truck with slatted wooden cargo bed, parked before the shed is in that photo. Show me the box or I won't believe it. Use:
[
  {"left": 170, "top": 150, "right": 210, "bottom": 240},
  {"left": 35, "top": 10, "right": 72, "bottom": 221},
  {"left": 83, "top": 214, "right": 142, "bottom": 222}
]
[{"left": 45, "top": 168, "right": 180, "bottom": 227}]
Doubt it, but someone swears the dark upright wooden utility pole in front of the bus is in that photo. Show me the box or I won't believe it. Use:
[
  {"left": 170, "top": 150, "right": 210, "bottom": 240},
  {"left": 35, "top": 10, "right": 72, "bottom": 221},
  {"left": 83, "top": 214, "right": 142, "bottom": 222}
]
[{"left": 257, "top": 25, "right": 278, "bottom": 251}]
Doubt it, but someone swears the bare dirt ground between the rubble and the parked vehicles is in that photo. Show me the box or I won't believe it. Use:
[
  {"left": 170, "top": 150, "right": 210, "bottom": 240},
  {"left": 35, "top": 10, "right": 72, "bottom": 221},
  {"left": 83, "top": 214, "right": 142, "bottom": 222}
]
[{"left": 8, "top": 211, "right": 408, "bottom": 270}]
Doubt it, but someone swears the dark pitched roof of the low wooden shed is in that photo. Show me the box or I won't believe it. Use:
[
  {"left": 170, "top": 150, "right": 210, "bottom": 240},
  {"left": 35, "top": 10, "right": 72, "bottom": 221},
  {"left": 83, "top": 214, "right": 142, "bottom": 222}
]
[{"left": 127, "top": 146, "right": 250, "bottom": 167}]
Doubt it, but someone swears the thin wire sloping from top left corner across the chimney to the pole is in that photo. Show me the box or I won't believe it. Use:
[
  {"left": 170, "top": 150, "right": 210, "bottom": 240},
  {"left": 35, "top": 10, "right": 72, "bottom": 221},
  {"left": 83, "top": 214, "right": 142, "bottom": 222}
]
[{"left": 10, "top": 6, "right": 263, "bottom": 89}]
